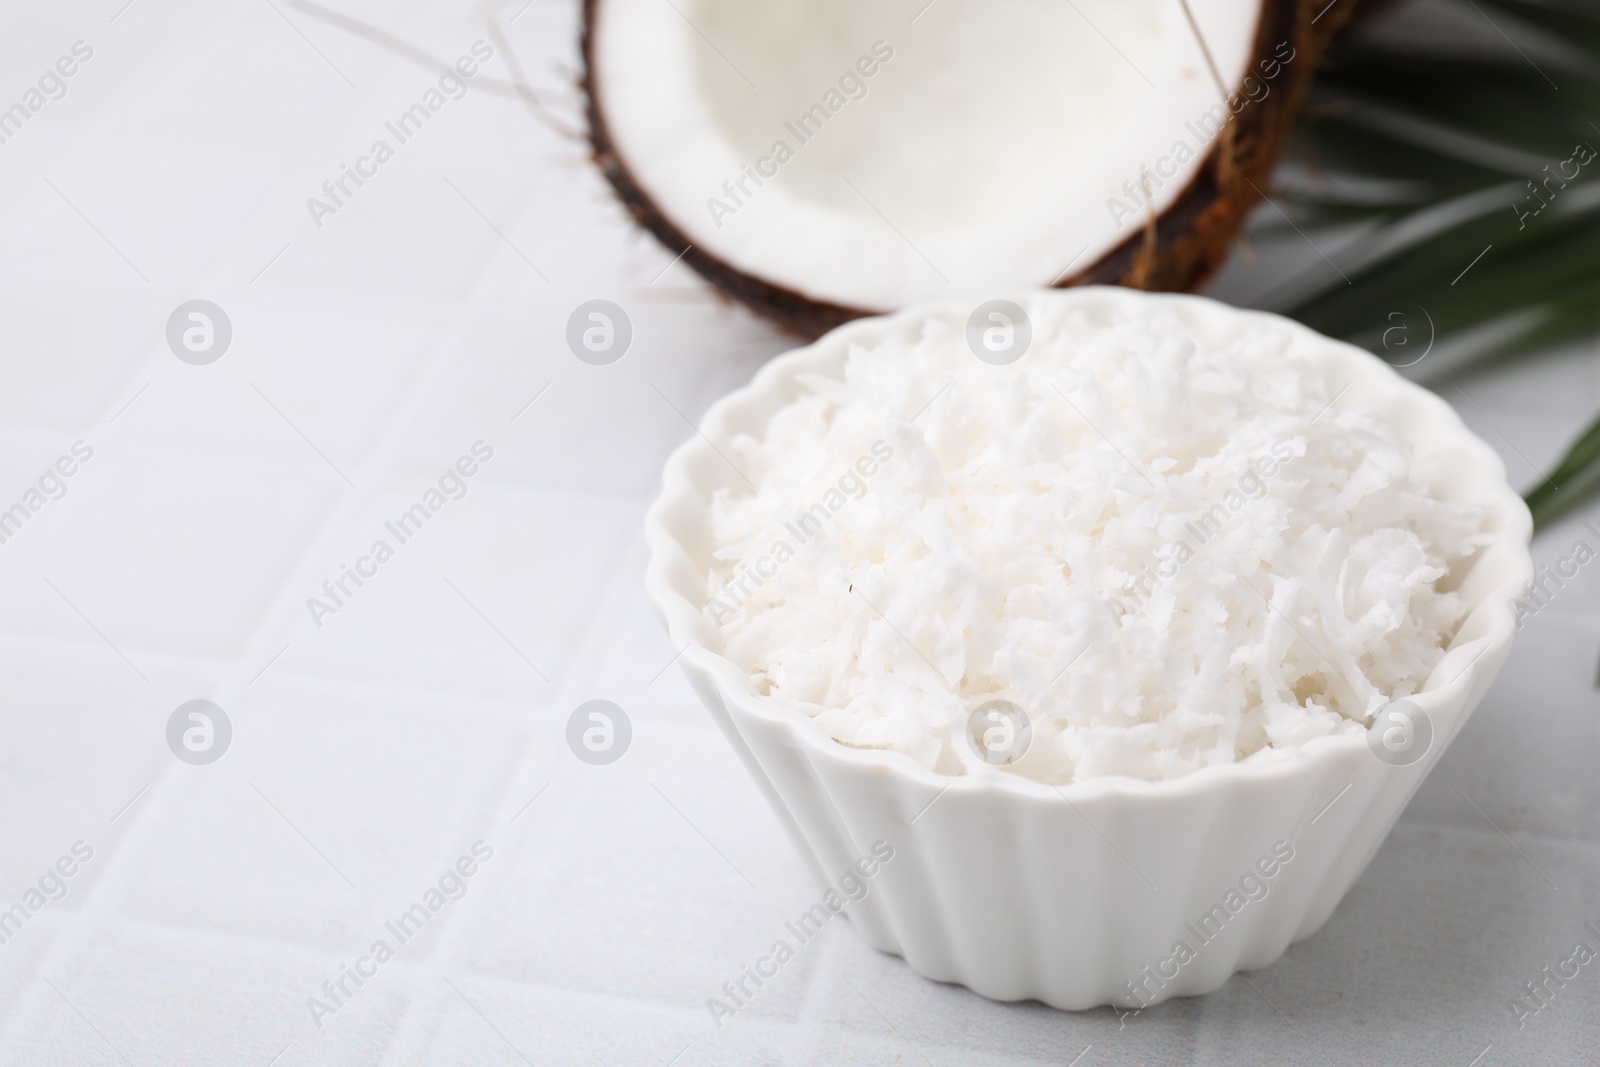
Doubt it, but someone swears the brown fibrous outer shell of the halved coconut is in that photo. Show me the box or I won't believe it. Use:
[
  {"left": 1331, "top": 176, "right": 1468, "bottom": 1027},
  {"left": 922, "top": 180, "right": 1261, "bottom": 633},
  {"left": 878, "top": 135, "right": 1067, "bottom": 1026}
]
[{"left": 581, "top": 0, "right": 1363, "bottom": 338}]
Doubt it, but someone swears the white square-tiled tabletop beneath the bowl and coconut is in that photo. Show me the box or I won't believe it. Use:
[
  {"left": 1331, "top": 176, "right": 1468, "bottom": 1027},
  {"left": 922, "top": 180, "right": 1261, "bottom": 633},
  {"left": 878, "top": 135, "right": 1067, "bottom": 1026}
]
[{"left": 0, "top": 0, "right": 1600, "bottom": 1067}]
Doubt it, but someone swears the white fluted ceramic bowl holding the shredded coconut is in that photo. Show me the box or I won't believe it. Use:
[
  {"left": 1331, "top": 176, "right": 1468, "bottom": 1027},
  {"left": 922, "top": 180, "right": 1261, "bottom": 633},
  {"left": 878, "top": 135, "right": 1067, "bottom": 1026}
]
[{"left": 646, "top": 288, "right": 1533, "bottom": 1009}]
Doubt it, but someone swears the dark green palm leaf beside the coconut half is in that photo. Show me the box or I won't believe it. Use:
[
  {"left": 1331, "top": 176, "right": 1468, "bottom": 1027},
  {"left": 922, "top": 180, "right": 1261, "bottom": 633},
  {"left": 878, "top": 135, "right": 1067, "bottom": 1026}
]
[{"left": 1254, "top": 0, "right": 1600, "bottom": 523}]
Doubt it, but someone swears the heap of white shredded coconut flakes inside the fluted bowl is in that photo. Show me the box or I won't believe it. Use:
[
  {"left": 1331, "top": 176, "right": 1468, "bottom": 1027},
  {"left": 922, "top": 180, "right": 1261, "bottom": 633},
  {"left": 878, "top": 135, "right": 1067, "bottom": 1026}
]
[{"left": 706, "top": 309, "right": 1488, "bottom": 784}]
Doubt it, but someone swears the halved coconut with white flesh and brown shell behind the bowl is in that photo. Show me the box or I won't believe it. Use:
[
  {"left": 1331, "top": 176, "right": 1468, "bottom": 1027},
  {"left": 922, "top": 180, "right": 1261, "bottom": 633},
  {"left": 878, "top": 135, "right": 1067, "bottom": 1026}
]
[{"left": 582, "top": 0, "right": 1354, "bottom": 334}]
